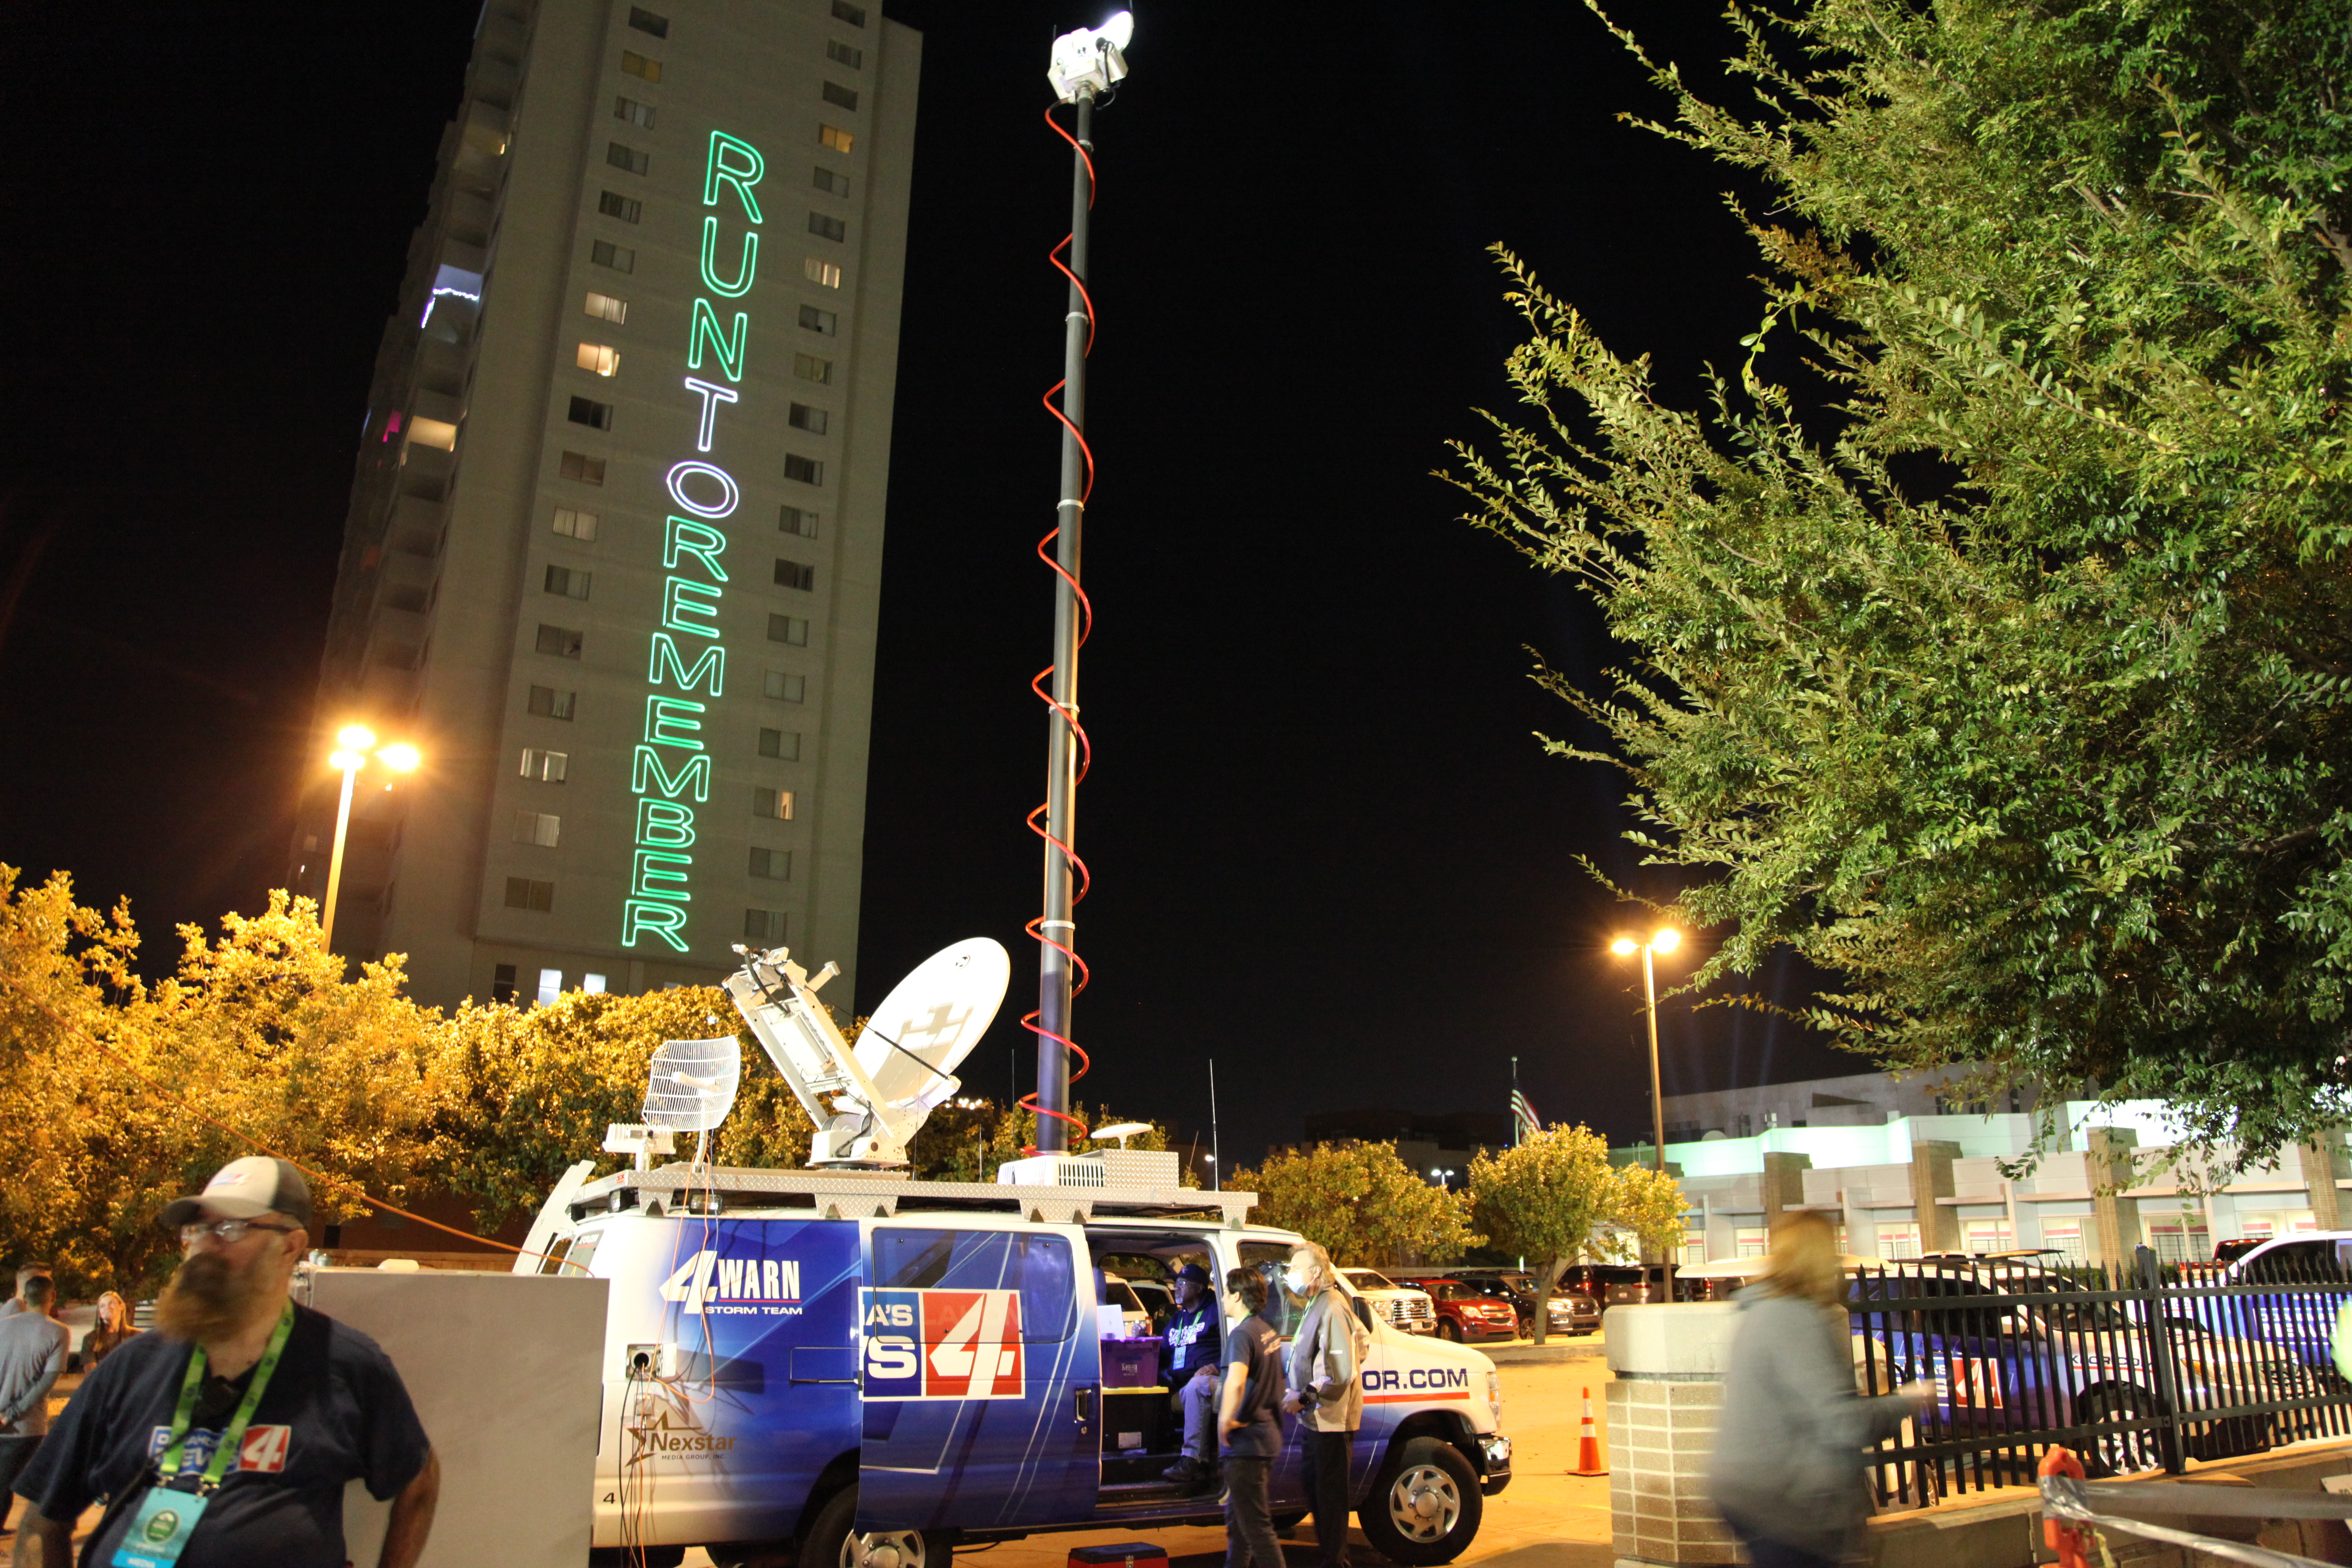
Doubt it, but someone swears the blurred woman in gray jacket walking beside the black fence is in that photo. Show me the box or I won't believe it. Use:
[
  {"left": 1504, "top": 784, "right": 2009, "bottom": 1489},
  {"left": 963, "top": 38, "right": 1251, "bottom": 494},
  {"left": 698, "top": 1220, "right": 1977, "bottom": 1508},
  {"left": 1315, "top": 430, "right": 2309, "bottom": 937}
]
[{"left": 1707, "top": 1213, "right": 1936, "bottom": 1568}]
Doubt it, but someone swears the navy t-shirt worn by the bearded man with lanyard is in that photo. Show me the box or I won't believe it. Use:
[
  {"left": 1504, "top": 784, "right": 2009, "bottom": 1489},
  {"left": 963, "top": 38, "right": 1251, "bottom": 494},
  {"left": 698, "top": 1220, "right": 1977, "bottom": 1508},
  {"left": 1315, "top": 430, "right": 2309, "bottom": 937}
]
[{"left": 16, "top": 1307, "right": 431, "bottom": 1568}]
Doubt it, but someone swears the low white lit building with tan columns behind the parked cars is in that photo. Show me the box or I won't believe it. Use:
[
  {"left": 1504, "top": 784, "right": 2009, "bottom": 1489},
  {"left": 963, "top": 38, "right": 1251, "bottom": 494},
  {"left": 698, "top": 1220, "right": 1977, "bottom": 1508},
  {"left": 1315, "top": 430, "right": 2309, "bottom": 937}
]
[{"left": 1646, "top": 1079, "right": 2352, "bottom": 1265}]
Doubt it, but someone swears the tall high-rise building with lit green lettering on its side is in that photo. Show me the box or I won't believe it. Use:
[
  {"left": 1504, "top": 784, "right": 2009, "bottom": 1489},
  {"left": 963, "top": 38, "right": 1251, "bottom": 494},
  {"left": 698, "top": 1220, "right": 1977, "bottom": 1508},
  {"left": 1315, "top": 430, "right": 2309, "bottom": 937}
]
[{"left": 297, "top": 0, "right": 922, "bottom": 1004}]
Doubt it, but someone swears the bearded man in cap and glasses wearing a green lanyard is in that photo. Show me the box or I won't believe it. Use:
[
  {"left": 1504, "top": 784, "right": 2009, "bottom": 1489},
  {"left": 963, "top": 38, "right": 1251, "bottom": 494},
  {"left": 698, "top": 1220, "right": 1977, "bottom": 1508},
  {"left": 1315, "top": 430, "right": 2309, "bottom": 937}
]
[{"left": 16, "top": 1154, "right": 440, "bottom": 1568}]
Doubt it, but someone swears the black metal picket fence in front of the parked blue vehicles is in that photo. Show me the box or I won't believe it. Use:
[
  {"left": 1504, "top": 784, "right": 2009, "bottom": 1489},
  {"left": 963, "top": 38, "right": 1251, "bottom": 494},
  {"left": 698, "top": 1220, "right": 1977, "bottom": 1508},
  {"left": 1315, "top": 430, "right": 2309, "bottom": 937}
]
[{"left": 1847, "top": 1246, "right": 2352, "bottom": 1504}]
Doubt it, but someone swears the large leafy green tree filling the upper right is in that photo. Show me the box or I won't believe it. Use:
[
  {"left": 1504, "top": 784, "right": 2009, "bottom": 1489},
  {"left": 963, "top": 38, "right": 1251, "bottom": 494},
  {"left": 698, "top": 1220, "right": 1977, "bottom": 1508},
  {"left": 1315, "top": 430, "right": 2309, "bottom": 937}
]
[{"left": 1454, "top": 0, "right": 2352, "bottom": 1161}]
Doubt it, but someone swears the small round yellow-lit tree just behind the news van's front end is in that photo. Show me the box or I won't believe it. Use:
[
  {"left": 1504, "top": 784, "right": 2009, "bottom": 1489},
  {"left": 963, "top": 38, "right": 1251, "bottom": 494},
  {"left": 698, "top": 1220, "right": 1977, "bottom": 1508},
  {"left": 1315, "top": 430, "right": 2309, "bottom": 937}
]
[{"left": 1228, "top": 1142, "right": 1482, "bottom": 1267}]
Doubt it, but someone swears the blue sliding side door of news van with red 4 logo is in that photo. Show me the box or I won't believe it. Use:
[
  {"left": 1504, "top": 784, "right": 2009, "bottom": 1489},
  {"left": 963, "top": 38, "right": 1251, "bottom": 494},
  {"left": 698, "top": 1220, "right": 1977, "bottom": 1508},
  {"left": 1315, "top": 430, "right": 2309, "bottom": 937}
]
[{"left": 856, "top": 1215, "right": 1103, "bottom": 1530}]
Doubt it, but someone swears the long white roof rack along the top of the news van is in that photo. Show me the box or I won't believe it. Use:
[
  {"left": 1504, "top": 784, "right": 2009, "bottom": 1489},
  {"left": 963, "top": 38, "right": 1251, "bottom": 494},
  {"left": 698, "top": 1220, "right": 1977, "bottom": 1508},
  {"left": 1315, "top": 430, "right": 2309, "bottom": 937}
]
[{"left": 569, "top": 1161, "right": 1259, "bottom": 1230}]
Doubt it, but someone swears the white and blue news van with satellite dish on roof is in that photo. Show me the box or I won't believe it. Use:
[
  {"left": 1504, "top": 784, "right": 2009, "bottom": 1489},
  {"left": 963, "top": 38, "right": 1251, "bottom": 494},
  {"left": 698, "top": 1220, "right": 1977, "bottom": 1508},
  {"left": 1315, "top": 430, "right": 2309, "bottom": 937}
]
[{"left": 518, "top": 938, "right": 1510, "bottom": 1568}]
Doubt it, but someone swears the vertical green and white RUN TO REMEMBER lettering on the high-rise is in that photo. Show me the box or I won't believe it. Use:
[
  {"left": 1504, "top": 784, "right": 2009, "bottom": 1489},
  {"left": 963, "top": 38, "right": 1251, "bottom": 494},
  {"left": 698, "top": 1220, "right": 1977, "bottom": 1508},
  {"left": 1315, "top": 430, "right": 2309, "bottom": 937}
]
[{"left": 621, "top": 132, "right": 767, "bottom": 952}]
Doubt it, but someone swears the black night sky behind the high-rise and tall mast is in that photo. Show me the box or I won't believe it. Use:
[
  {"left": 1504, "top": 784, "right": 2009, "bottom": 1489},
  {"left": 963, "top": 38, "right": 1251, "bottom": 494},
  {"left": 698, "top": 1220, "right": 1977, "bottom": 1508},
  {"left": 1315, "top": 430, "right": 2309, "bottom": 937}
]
[{"left": 0, "top": 0, "right": 1863, "bottom": 1164}]
